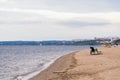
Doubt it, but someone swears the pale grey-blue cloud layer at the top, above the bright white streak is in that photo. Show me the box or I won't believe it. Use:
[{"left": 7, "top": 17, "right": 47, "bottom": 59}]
[{"left": 0, "top": 0, "right": 120, "bottom": 12}]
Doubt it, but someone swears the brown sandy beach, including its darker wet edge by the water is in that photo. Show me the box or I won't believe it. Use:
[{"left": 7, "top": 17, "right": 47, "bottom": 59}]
[{"left": 30, "top": 46, "right": 120, "bottom": 80}]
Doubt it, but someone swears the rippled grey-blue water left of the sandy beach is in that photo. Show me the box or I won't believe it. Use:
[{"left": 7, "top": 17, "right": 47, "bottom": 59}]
[{"left": 0, "top": 46, "right": 98, "bottom": 80}]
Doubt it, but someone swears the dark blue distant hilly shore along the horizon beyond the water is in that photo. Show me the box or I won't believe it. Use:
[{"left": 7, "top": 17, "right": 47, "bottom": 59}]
[{"left": 0, "top": 40, "right": 100, "bottom": 45}]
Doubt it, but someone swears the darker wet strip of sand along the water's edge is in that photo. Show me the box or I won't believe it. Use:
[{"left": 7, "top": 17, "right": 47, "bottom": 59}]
[{"left": 29, "top": 51, "right": 78, "bottom": 80}]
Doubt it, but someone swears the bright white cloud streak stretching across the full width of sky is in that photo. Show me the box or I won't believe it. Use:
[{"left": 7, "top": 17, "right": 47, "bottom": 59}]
[{"left": 0, "top": 8, "right": 120, "bottom": 22}]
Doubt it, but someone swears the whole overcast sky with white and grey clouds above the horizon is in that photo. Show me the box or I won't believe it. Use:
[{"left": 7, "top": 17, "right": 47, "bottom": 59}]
[{"left": 0, "top": 0, "right": 120, "bottom": 41}]
